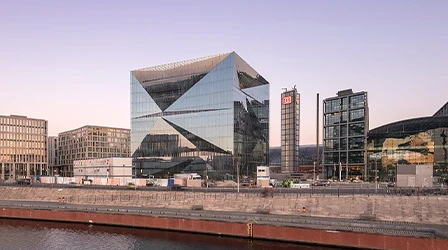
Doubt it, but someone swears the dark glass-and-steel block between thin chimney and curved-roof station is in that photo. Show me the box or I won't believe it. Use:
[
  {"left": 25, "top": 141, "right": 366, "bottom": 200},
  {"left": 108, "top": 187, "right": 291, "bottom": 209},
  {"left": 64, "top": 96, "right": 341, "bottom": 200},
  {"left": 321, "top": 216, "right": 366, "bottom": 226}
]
[{"left": 322, "top": 89, "right": 369, "bottom": 179}]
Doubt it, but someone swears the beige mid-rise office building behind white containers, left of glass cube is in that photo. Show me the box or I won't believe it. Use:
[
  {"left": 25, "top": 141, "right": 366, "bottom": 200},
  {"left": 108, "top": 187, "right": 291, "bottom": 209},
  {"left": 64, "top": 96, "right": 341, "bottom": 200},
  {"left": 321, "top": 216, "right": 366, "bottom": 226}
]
[{"left": 55, "top": 125, "right": 131, "bottom": 177}]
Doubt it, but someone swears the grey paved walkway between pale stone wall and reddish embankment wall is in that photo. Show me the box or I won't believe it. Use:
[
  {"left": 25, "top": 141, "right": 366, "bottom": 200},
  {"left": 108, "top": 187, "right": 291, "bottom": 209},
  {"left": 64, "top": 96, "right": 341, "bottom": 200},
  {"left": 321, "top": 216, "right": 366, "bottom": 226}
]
[{"left": 0, "top": 200, "right": 448, "bottom": 239}]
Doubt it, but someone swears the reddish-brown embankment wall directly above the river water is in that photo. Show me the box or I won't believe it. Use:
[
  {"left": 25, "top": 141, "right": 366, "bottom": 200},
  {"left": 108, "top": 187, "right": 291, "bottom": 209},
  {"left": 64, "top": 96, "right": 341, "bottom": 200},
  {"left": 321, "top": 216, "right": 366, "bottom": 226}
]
[{"left": 0, "top": 208, "right": 447, "bottom": 250}]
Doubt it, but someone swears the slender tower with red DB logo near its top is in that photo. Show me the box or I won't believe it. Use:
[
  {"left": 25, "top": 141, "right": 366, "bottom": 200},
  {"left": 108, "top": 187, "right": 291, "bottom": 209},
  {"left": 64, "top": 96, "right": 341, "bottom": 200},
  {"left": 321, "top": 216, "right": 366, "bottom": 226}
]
[{"left": 281, "top": 87, "right": 300, "bottom": 173}]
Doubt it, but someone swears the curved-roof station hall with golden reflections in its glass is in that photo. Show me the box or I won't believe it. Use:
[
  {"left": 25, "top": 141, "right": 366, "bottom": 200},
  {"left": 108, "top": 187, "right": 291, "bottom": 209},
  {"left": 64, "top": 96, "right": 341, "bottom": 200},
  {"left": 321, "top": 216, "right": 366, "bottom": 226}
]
[{"left": 368, "top": 116, "right": 448, "bottom": 181}]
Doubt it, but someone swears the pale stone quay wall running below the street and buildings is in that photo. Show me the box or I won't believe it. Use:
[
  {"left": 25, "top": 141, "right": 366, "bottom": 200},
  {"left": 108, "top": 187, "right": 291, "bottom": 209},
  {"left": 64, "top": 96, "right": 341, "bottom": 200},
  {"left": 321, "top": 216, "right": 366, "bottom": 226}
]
[{"left": 0, "top": 187, "right": 448, "bottom": 225}]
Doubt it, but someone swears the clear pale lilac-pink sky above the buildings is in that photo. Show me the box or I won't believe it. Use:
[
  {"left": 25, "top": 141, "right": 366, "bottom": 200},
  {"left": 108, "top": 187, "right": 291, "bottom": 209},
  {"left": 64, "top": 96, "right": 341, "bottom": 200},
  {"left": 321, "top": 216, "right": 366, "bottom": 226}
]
[{"left": 0, "top": 0, "right": 448, "bottom": 146}]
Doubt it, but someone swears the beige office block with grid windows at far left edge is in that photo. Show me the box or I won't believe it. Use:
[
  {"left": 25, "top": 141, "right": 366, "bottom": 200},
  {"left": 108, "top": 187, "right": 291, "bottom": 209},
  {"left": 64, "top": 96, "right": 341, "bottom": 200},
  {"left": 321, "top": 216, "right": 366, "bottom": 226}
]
[{"left": 0, "top": 115, "right": 48, "bottom": 180}]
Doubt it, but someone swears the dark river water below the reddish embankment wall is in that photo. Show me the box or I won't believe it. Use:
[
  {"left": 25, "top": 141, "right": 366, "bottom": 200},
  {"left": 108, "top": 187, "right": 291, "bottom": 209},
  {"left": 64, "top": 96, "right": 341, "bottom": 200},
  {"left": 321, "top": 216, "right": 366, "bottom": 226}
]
[{"left": 0, "top": 219, "right": 344, "bottom": 250}]
